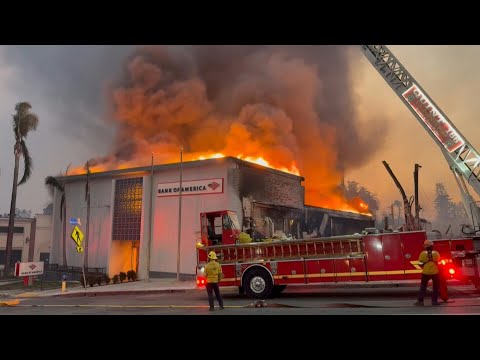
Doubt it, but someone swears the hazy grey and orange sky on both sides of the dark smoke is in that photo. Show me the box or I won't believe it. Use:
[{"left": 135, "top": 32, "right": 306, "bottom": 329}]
[{"left": 0, "top": 45, "right": 480, "bottom": 224}]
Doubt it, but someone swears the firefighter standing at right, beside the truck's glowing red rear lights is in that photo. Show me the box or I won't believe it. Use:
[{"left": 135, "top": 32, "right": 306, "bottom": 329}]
[{"left": 415, "top": 240, "right": 440, "bottom": 306}]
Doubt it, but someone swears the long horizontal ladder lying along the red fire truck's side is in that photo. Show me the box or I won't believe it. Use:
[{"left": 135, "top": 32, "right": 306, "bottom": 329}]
[{"left": 203, "top": 235, "right": 365, "bottom": 264}]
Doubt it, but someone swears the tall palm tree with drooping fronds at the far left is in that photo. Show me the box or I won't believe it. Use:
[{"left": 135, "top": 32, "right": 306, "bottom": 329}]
[{"left": 4, "top": 102, "right": 38, "bottom": 276}]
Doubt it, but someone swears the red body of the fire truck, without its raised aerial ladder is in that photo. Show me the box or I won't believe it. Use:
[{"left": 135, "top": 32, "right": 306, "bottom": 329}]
[{"left": 197, "top": 210, "right": 478, "bottom": 301}]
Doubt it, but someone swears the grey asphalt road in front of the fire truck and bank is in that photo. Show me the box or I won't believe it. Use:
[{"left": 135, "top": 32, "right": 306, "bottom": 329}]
[{"left": 0, "top": 286, "right": 480, "bottom": 316}]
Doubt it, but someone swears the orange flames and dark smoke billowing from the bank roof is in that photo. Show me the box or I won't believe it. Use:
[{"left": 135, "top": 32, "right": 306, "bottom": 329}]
[{"left": 70, "top": 46, "right": 381, "bottom": 214}]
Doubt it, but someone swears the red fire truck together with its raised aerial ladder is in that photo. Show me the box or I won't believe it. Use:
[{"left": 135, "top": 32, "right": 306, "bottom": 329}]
[{"left": 196, "top": 45, "right": 480, "bottom": 301}]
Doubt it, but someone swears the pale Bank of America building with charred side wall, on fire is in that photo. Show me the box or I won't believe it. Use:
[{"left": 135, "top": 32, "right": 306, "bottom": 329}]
[{"left": 51, "top": 157, "right": 373, "bottom": 278}]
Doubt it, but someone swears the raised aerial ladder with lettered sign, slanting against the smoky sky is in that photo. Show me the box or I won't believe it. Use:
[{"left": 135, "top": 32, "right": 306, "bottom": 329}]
[{"left": 361, "top": 45, "right": 480, "bottom": 233}]
